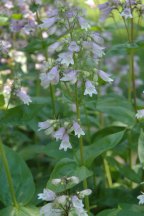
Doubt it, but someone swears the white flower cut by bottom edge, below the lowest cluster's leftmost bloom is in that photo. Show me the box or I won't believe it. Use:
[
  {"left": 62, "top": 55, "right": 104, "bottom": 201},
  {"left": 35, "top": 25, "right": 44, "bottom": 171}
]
[{"left": 40, "top": 203, "right": 62, "bottom": 216}]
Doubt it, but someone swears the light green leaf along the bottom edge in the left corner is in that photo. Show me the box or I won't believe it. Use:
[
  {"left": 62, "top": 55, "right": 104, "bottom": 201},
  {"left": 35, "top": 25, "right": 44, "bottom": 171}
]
[{"left": 0, "top": 206, "right": 39, "bottom": 216}]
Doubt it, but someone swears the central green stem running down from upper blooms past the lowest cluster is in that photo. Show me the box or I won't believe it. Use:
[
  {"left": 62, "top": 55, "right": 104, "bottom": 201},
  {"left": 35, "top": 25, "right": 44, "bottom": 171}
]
[{"left": 75, "top": 83, "right": 90, "bottom": 215}]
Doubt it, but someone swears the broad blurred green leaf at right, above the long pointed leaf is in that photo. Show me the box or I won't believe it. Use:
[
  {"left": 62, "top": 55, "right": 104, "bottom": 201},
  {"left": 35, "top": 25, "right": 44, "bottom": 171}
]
[{"left": 96, "top": 95, "right": 135, "bottom": 126}]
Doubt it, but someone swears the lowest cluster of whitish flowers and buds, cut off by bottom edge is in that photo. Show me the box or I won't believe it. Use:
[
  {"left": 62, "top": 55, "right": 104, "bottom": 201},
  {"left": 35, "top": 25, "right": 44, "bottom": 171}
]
[{"left": 38, "top": 176, "right": 92, "bottom": 216}]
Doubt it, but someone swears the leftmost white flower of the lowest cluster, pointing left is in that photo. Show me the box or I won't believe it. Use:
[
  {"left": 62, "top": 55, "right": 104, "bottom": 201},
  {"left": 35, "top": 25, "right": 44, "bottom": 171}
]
[{"left": 38, "top": 189, "right": 56, "bottom": 201}]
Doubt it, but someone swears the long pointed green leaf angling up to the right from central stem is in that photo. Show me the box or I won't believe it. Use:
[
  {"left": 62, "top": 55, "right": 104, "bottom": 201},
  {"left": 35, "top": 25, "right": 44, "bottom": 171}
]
[{"left": 76, "top": 131, "right": 125, "bottom": 167}]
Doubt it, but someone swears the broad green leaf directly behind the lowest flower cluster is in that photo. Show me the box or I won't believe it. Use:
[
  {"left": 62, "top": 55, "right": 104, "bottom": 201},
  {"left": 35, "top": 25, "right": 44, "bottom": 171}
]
[{"left": 47, "top": 158, "right": 92, "bottom": 192}]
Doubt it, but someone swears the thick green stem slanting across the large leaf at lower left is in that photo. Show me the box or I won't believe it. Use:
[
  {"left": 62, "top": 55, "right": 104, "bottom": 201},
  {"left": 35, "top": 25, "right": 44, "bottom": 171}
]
[{"left": 0, "top": 139, "right": 19, "bottom": 208}]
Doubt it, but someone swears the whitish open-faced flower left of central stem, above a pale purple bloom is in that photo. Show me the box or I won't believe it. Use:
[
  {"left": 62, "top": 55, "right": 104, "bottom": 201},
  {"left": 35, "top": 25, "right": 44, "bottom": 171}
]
[{"left": 58, "top": 51, "right": 74, "bottom": 67}]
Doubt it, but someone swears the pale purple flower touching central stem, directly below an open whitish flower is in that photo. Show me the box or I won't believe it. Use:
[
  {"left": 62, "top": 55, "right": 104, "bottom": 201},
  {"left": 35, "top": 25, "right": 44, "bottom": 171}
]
[{"left": 60, "top": 70, "right": 77, "bottom": 84}]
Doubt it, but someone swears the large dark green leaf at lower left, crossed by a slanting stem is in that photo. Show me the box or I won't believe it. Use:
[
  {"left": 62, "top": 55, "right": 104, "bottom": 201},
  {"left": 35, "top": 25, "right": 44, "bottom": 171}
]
[{"left": 0, "top": 146, "right": 35, "bottom": 206}]
